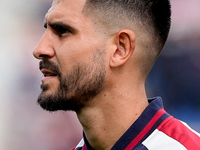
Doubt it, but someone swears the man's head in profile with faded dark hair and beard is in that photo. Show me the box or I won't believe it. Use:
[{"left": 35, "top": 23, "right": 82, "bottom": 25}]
[{"left": 34, "top": 0, "right": 171, "bottom": 111}]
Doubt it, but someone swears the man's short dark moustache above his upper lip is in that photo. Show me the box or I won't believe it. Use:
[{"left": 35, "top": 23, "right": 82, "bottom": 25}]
[{"left": 39, "top": 59, "right": 61, "bottom": 76}]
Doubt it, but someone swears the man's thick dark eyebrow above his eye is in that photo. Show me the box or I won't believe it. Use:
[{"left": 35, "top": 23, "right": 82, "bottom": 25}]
[{"left": 44, "top": 21, "right": 78, "bottom": 33}]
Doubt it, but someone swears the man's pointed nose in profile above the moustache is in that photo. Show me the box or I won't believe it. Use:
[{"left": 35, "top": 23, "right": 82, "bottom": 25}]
[{"left": 33, "top": 31, "right": 55, "bottom": 59}]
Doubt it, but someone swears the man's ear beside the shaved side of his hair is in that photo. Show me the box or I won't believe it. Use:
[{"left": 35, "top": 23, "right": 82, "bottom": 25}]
[{"left": 110, "top": 29, "right": 135, "bottom": 67}]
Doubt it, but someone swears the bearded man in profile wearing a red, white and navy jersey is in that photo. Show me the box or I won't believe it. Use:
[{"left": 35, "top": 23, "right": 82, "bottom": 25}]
[{"left": 34, "top": 0, "right": 200, "bottom": 150}]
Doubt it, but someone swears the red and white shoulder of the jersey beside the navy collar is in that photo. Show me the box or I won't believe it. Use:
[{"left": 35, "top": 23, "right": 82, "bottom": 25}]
[{"left": 143, "top": 118, "right": 200, "bottom": 150}]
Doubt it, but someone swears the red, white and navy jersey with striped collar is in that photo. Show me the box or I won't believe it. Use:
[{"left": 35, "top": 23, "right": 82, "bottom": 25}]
[{"left": 73, "top": 97, "right": 200, "bottom": 150}]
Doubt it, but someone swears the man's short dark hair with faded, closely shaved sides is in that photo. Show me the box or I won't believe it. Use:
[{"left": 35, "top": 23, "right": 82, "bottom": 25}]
[{"left": 83, "top": 0, "right": 171, "bottom": 73}]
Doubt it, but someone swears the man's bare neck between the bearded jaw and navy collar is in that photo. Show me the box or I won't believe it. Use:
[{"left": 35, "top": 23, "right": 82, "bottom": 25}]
[{"left": 77, "top": 82, "right": 148, "bottom": 150}]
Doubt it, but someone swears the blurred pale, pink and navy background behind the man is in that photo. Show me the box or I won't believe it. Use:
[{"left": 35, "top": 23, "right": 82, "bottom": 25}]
[{"left": 0, "top": 0, "right": 200, "bottom": 150}]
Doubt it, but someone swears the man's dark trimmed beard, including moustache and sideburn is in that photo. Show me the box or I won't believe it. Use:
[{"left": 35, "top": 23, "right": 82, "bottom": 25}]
[{"left": 37, "top": 51, "right": 106, "bottom": 111}]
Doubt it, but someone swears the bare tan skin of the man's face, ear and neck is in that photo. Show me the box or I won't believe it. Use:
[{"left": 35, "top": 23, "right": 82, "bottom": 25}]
[{"left": 33, "top": 0, "right": 148, "bottom": 150}]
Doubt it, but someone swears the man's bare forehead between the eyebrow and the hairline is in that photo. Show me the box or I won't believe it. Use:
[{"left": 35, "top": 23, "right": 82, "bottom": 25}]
[{"left": 45, "top": 0, "right": 88, "bottom": 28}]
